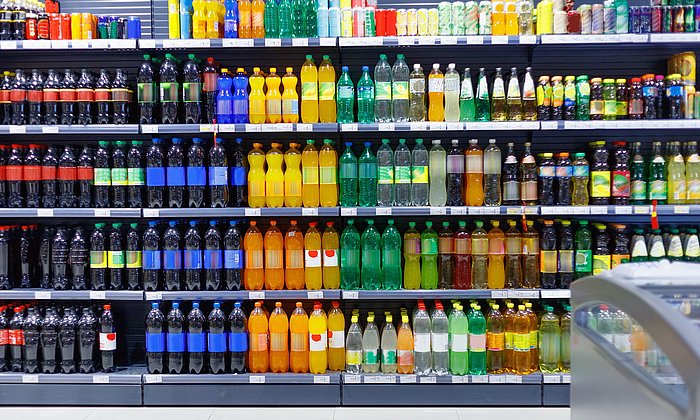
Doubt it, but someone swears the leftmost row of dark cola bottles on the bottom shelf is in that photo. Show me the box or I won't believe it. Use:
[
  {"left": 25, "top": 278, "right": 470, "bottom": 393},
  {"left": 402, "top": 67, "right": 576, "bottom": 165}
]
[{"left": 0, "top": 302, "right": 117, "bottom": 373}]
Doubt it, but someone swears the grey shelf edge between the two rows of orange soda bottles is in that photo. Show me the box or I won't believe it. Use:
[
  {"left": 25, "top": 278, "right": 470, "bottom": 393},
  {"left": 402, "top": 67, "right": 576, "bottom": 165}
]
[{"left": 145, "top": 289, "right": 341, "bottom": 300}]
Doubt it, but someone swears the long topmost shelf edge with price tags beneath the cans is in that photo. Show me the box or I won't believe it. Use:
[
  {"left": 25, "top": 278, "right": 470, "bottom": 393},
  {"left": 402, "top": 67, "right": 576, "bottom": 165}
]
[{"left": 0, "top": 32, "right": 700, "bottom": 51}]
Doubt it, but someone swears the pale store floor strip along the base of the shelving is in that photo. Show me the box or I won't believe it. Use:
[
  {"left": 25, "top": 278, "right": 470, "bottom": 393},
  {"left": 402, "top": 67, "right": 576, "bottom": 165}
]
[{"left": 0, "top": 407, "right": 570, "bottom": 420}]
